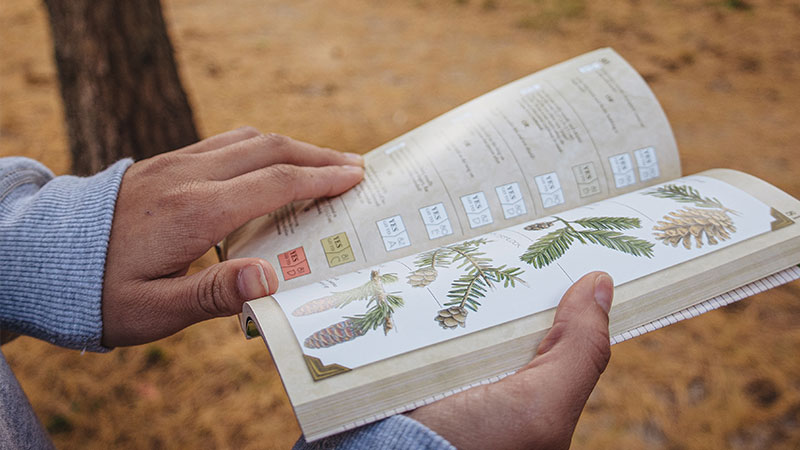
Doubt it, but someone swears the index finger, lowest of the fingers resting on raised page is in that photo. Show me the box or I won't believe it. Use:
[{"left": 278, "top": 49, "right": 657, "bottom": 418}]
[{"left": 210, "top": 164, "right": 364, "bottom": 234}]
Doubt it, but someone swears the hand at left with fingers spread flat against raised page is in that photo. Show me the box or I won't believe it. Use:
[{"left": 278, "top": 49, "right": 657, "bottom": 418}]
[{"left": 102, "top": 127, "right": 364, "bottom": 347}]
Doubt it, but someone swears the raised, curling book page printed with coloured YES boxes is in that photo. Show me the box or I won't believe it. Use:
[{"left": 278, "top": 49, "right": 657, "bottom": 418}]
[{"left": 226, "top": 49, "right": 680, "bottom": 289}]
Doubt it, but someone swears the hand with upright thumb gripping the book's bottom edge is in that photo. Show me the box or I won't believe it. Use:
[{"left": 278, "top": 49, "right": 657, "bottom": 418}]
[{"left": 408, "top": 272, "right": 614, "bottom": 449}]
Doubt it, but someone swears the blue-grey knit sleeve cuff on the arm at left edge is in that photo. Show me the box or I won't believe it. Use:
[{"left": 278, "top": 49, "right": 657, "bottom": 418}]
[{"left": 0, "top": 157, "right": 132, "bottom": 351}]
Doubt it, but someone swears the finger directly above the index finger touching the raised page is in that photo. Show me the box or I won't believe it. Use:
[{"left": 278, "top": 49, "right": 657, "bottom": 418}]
[{"left": 203, "top": 133, "right": 364, "bottom": 180}]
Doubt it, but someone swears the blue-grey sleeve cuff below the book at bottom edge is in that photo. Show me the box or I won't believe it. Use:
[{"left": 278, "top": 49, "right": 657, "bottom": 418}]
[{"left": 292, "top": 414, "right": 455, "bottom": 450}]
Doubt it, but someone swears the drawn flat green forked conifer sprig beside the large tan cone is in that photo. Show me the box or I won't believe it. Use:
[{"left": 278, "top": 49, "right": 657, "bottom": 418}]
[{"left": 519, "top": 216, "right": 653, "bottom": 269}]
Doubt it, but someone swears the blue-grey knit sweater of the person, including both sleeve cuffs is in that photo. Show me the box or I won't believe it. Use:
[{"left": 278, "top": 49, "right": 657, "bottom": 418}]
[{"left": 0, "top": 158, "right": 453, "bottom": 449}]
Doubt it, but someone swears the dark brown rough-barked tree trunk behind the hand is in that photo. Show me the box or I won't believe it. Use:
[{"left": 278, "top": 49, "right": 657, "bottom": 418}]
[{"left": 44, "top": 0, "right": 198, "bottom": 175}]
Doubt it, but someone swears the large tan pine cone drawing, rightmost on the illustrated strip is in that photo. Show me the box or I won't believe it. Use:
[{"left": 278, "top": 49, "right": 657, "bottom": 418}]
[{"left": 653, "top": 208, "right": 736, "bottom": 250}]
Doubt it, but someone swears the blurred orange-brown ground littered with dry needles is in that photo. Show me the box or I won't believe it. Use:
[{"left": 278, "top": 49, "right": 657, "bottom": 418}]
[{"left": 0, "top": 0, "right": 800, "bottom": 449}]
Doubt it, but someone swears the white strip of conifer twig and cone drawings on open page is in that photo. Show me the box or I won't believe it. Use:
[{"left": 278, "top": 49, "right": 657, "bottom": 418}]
[{"left": 274, "top": 176, "right": 773, "bottom": 371}]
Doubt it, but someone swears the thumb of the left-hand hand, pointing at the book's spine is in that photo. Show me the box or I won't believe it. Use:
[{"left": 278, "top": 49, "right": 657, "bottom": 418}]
[{"left": 108, "top": 258, "right": 278, "bottom": 346}]
